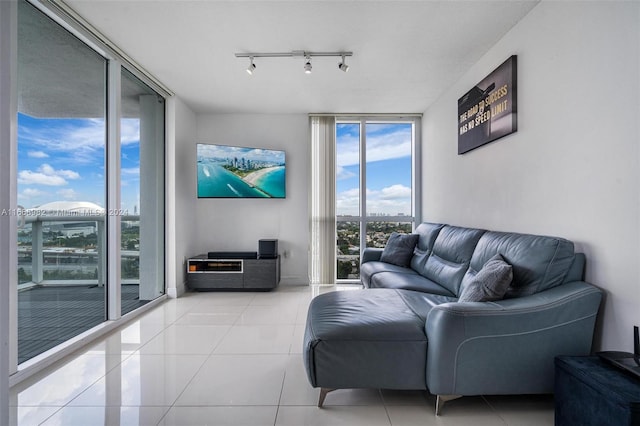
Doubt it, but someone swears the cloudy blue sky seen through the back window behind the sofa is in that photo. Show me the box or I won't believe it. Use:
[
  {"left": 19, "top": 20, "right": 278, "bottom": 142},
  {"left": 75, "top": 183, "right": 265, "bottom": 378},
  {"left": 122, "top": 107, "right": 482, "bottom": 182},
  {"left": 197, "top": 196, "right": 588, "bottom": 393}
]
[{"left": 336, "top": 123, "right": 412, "bottom": 215}]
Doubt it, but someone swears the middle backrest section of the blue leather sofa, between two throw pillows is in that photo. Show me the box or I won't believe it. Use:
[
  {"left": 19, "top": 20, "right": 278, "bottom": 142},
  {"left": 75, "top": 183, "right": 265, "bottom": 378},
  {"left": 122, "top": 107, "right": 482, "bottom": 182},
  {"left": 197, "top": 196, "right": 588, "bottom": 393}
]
[{"left": 411, "top": 225, "right": 486, "bottom": 295}]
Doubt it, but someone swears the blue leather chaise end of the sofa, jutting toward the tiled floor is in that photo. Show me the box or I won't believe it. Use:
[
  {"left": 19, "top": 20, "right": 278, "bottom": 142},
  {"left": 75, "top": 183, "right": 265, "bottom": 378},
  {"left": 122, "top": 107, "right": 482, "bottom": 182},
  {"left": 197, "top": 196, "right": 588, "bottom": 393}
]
[{"left": 303, "top": 289, "right": 429, "bottom": 389}]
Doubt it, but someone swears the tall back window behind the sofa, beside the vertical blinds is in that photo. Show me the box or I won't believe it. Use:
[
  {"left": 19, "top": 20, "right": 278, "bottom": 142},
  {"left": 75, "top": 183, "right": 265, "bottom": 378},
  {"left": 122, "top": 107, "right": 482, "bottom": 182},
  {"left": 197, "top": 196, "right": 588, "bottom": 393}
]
[{"left": 336, "top": 118, "right": 419, "bottom": 280}]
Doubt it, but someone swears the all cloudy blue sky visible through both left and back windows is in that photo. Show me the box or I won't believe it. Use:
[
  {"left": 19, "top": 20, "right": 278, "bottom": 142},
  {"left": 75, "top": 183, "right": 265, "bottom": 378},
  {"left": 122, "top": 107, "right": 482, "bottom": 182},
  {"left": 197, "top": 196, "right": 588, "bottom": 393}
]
[{"left": 18, "top": 114, "right": 412, "bottom": 215}]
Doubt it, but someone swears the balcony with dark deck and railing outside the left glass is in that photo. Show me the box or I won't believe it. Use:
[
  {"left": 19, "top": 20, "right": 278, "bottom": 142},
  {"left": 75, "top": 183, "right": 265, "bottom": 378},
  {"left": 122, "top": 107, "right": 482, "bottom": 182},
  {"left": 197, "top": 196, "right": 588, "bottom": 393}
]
[{"left": 18, "top": 209, "right": 150, "bottom": 363}]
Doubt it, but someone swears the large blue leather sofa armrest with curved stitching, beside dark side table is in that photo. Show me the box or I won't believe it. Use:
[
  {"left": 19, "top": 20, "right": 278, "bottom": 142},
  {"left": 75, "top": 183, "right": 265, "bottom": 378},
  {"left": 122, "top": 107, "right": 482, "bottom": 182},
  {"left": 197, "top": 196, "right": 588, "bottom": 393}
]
[{"left": 425, "top": 281, "right": 602, "bottom": 395}]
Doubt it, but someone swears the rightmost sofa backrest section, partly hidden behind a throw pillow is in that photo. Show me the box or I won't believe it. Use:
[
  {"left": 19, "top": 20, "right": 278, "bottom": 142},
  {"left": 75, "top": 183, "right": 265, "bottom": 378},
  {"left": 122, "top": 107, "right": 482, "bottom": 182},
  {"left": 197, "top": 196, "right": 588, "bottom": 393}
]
[{"left": 456, "top": 231, "right": 575, "bottom": 298}]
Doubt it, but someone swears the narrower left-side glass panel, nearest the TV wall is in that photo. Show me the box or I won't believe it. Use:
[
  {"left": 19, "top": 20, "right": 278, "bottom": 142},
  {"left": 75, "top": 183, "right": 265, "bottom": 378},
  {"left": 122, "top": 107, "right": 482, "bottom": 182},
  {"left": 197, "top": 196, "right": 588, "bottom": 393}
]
[{"left": 118, "top": 69, "right": 165, "bottom": 315}]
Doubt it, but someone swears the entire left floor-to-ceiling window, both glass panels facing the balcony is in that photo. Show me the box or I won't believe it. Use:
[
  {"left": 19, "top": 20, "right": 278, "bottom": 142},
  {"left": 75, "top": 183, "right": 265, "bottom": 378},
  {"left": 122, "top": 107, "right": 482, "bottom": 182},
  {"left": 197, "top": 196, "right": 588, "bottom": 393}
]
[{"left": 15, "top": 0, "right": 165, "bottom": 364}]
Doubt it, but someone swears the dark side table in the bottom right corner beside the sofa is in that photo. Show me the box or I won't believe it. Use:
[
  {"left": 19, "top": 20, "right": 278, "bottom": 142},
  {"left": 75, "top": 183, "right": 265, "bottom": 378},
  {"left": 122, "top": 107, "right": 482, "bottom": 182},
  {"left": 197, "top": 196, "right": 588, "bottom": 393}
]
[{"left": 554, "top": 356, "right": 640, "bottom": 426}]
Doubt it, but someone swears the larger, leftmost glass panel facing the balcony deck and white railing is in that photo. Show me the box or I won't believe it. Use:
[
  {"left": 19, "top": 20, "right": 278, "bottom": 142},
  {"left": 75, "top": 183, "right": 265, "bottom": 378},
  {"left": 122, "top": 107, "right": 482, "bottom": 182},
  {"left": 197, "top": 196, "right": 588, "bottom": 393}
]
[{"left": 17, "top": 2, "right": 107, "bottom": 363}]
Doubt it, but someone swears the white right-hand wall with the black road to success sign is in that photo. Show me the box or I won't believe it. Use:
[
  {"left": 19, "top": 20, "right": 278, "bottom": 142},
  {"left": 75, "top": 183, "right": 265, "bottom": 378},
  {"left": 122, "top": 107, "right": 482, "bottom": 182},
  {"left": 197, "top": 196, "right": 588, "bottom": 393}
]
[{"left": 423, "top": 2, "right": 640, "bottom": 351}]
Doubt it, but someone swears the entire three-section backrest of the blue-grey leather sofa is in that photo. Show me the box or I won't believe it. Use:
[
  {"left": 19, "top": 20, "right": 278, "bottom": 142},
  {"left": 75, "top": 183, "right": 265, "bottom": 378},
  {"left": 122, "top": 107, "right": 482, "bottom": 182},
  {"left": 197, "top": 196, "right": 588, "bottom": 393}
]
[{"left": 411, "top": 222, "right": 585, "bottom": 298}]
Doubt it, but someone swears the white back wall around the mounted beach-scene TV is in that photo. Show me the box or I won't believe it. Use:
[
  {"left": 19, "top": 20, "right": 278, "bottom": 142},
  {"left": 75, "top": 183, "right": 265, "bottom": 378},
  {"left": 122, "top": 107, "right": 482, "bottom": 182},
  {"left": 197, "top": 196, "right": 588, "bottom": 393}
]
[{"left": 194, "top": 114, "right": 309, "bottom": 285}]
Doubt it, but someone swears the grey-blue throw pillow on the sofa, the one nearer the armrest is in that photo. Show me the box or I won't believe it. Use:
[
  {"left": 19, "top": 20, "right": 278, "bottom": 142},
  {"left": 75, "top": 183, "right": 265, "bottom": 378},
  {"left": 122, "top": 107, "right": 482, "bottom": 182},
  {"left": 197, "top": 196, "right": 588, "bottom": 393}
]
[{"left": 458, "top": 254, "right": 513, "bottom": 302}]
